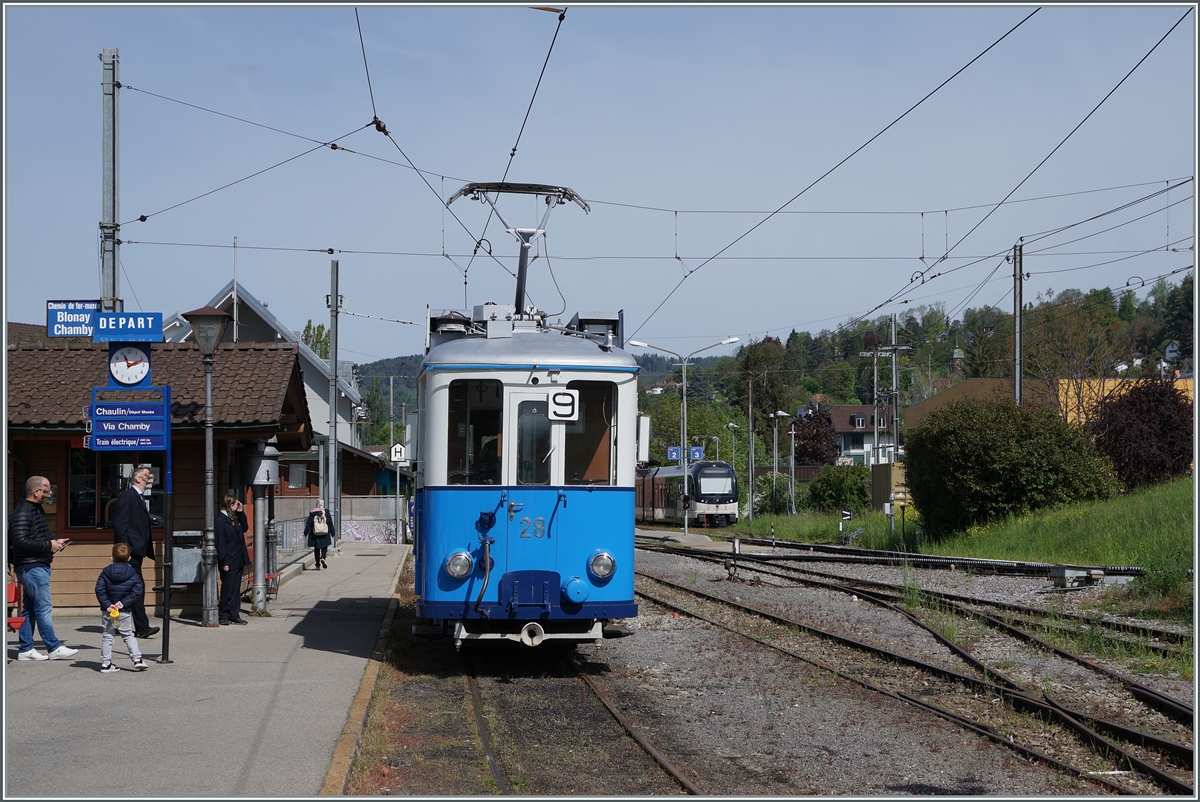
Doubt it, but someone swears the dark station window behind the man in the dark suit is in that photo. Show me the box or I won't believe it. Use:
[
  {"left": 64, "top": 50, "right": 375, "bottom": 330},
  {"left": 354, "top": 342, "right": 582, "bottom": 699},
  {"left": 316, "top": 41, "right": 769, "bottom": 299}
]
[{"left": 67, "top": 448, "right": 167, "bottom": 528}]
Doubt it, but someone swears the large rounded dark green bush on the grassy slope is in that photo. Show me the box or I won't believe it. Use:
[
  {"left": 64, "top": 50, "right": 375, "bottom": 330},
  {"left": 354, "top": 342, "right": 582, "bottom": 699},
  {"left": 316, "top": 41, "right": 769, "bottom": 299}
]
[{"left": 905, "top": 399, "right": 1117, "bottom": 538}]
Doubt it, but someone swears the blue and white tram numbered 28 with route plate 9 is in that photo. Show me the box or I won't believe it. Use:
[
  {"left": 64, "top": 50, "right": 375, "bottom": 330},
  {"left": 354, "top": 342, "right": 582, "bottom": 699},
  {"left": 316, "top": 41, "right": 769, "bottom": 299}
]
[{"left": 410, "top": 185, "right": 638, "bottom": 646}]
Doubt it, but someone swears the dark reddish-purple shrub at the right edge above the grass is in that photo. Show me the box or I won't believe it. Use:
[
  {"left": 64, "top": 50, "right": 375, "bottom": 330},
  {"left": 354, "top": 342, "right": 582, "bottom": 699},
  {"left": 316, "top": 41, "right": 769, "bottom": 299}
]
[{"left": 1090, "top": 377, "right": 1192, "bottom": 490}]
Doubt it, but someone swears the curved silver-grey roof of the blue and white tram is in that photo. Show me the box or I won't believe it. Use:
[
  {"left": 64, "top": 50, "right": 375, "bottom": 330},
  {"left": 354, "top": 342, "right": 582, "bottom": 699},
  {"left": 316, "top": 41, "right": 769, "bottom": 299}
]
[{"left": 421, "top": 330, "right": 638, "bottom": 373}]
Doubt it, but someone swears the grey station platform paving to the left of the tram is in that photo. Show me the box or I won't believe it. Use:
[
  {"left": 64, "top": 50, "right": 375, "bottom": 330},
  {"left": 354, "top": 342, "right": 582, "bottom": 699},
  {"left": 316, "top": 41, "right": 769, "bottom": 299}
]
[{"left": 4, "top": 543, "right": 410, "bottom": 798}]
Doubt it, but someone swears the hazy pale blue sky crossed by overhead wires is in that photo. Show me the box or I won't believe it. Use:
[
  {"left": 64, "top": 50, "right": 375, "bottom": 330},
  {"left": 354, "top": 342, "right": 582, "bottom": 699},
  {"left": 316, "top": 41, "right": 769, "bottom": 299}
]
[{"left": 4, "top": 5, "right": 1196, "bottom": 363}]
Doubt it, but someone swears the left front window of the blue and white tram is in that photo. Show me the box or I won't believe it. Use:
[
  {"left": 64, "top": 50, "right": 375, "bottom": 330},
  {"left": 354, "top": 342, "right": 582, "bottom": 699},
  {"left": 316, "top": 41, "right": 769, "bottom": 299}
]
[{"left": 446, "top": 378, "right": 504, "bottom": 485}]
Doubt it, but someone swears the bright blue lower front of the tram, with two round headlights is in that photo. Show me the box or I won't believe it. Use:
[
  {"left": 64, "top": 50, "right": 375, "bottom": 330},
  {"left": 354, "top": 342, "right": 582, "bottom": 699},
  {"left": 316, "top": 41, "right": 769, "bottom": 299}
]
[{"left": 415, "top": 485, "right": 637, "bottom": 622}]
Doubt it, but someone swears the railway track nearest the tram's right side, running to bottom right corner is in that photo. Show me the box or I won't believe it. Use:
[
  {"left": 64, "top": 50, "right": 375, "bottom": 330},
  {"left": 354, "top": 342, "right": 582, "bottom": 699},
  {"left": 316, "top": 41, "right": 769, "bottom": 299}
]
[{"left": 638, "top": 574, "right": 1192, "bottom": 795}]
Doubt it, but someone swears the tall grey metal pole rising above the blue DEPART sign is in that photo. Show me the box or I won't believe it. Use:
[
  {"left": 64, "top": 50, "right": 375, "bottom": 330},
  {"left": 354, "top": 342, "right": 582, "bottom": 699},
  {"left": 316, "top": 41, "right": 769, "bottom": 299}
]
[{"left": 100, "top": 47, "right": 125, "bottom": 312}]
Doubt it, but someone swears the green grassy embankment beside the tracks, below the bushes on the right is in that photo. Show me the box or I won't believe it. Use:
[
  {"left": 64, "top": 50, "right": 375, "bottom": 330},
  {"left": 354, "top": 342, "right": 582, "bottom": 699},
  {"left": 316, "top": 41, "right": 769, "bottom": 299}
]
[{"left": 738, "top": 477, "right": 1195, "bottom": 620}]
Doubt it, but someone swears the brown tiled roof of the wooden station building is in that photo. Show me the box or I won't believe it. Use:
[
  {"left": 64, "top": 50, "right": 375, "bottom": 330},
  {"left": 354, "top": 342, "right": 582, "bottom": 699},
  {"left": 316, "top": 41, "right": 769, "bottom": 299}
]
[{"left": 6, "top": 342, "right": 310, "bottom": 432}]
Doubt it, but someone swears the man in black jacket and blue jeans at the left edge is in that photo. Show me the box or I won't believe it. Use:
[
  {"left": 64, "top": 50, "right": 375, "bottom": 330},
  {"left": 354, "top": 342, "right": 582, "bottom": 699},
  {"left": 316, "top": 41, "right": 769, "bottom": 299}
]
[{"left": 8, "top": 477, "right": 79, "bottom": 660}]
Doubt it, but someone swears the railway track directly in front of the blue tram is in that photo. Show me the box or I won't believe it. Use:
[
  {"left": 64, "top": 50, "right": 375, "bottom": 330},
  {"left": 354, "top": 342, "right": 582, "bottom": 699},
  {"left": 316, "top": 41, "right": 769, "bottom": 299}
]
[{"left": 463, "top": 648, "right": 704, "bottom": 795}]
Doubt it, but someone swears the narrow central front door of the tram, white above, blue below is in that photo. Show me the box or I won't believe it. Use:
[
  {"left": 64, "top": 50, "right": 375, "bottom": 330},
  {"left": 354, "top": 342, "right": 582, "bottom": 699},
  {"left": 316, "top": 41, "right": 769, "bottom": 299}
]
[{"left": 505, "top": 390, "right": 565, "bottom": 570}]
